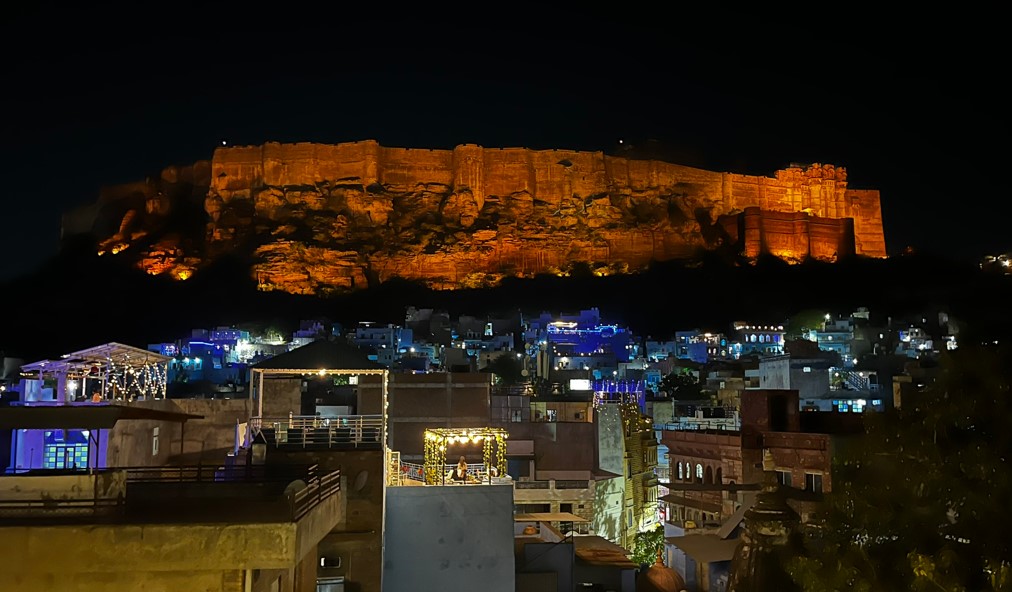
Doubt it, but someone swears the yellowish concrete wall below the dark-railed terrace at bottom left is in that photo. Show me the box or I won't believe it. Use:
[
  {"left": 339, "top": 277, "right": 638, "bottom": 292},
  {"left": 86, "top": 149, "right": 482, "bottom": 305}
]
[{"left": 0, "top": 495, "right": 342, "bottom": 592}]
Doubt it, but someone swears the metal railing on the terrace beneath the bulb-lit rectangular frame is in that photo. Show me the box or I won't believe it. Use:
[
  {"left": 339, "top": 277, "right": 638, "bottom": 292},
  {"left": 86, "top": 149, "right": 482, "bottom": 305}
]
[{"left": 249, "top": 415, "right": 383, "bottom": 448}]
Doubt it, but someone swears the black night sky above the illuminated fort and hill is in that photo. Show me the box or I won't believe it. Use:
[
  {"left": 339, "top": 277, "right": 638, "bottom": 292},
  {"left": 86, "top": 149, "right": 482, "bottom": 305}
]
[{"left": 0, "top": 10, "right": 1012, "bottom": 279}]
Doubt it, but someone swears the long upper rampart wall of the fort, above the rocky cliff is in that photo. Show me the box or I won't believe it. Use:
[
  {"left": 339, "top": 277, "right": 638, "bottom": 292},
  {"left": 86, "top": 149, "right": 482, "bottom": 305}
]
[{"left": 212, "top": 141, "right": 724, "bottom": 205}]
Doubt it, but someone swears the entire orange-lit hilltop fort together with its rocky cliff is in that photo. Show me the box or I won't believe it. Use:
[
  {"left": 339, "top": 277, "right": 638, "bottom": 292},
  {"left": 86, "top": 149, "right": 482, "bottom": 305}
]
[{"left": 65, "top": 141, "right": 886, "bottom": 293}]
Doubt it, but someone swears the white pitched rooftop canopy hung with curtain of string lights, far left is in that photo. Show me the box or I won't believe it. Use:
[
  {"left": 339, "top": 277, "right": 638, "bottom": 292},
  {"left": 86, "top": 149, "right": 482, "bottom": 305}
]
[{"left": 21, "top": 342, "right": 172, "bottom": 403}]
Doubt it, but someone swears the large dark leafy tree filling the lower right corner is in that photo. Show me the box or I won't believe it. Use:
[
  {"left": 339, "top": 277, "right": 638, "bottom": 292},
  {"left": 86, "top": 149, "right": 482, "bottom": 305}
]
[{"left": 789, "top": 347, "right": 1012, "bottom": 592}]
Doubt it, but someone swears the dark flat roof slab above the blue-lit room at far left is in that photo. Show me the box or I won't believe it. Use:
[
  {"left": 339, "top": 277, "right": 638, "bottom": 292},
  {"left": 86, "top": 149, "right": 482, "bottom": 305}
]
[{"left": 0, "top": 403, "right": 203, "bottom": 429}]
